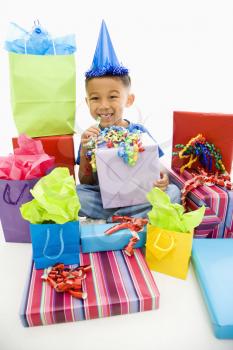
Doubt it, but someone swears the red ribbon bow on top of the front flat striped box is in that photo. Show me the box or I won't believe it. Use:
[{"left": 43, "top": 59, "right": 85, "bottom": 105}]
[{"left": 41, "top": 264, "right": 91, "bottom": 299}]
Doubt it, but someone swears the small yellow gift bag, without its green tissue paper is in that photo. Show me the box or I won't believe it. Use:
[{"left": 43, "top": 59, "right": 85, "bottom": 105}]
[{"left": 146, "top": 225, "right": 193, "bottom": 279}]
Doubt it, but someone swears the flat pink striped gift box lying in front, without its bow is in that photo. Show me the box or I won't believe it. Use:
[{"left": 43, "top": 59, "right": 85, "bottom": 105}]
[{"left": 20, "top": 249, "right": 159, "bottom": 327}]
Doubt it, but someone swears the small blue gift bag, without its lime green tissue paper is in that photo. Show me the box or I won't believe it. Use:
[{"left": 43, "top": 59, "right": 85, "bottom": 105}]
[{"left": 30, "top": 221, "right": 80, "bottom": 269}]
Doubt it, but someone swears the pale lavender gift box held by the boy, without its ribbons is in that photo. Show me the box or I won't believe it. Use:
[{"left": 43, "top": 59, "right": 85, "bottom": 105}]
[{"left": 96, "top": 133, "right": 160, "bottom": 208}]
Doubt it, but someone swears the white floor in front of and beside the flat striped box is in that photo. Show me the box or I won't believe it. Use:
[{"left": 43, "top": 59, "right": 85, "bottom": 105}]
[{"left": 0, "top": 228, "right": 233, "bottom": 350}]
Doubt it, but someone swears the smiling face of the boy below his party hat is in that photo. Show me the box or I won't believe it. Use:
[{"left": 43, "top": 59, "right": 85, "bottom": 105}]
[{"left": 86, "top": 77, "right": 134, "bottom": 127}]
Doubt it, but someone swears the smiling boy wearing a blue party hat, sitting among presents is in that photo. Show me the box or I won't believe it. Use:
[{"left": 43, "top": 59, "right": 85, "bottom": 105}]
[{"left": 77, "top": 22, "right": 180, "bottom": 222}]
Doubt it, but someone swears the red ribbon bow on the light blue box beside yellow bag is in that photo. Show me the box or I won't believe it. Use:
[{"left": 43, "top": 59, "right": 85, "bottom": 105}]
[{"left": 105, "top": 215, "right": 148, "bottom": 256}]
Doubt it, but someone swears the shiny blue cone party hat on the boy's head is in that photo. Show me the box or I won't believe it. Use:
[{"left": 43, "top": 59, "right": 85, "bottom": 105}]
[{"left": 85, "top": 20, "right": 128, "bottom": 78}]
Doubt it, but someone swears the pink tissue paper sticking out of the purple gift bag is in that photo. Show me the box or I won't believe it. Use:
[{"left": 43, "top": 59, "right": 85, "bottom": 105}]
[{"left": 0, "top": 135, "right": 54, "bottom": 180}]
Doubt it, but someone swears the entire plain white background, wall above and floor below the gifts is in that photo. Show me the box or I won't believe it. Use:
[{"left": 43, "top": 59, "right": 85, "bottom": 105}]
[{"left": 0, "top": 0, "right": 233, "bottom": 350}]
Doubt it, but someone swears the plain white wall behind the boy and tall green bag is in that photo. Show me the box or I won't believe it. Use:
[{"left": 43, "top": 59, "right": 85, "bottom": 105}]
[{"left": 0, "top": 0, "right": 233, "bottom": 154}]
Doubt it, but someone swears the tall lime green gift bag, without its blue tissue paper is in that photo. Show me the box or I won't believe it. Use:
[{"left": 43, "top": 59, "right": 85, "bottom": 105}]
[{"left": 9, "top": 53, "right": 76, "bottom": 137}]
